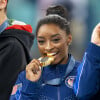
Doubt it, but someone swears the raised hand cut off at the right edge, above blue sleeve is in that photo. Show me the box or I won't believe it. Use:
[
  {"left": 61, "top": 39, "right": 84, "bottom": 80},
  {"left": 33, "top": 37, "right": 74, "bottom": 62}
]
[{"left": 91, "top": 23, "right": 100, "bottom": 46}]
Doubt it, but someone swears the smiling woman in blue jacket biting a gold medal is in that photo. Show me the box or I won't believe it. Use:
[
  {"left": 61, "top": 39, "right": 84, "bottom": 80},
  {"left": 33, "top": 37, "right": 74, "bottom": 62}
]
[{"left": 11, "top": 4, "right": 100, "bottom": 100}]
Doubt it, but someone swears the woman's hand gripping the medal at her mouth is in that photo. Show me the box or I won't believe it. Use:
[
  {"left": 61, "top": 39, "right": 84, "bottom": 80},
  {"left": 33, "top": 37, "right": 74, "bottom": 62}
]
[{"left": 26, "top": 59, "right": 41, "bottom": 82}]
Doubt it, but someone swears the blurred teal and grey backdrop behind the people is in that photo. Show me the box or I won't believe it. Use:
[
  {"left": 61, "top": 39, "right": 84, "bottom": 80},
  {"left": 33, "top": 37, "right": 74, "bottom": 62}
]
[{"left": 7, "top": 0, "right": 100, "bottom": 60}]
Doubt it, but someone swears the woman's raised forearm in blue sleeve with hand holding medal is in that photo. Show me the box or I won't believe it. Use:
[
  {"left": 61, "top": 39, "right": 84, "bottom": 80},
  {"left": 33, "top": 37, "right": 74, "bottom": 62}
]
[{"left": 19, "top": 59, "right": 41, "bottom": 100}]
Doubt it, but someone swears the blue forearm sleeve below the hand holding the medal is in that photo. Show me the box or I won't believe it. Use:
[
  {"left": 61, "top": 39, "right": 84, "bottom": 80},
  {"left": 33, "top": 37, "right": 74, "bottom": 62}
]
[{"left": 18, "top": 79, "right": 39, "bottom": 100}]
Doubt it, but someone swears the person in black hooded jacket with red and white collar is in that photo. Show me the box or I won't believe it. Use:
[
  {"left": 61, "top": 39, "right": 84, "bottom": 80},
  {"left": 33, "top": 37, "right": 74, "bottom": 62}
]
[{"left": 0, "top": 0, "right": 34, "bottom": 100}]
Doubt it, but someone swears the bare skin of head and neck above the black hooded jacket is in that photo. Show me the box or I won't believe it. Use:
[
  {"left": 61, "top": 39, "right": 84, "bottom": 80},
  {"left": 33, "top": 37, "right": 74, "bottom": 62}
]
[{"left": 0, "top": 0, "right": 7, "bottom": 25}]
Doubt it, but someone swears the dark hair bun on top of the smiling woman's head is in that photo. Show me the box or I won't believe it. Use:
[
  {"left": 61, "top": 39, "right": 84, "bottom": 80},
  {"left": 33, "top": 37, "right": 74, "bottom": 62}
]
[{"left": 46, "top": 5, "right": 69, "bottom": 20}]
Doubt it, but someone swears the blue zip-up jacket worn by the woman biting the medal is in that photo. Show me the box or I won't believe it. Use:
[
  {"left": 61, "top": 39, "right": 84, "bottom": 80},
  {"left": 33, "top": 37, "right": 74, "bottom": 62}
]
[{"left": 10, "top": 56, "right": 79, "bottom": 100}]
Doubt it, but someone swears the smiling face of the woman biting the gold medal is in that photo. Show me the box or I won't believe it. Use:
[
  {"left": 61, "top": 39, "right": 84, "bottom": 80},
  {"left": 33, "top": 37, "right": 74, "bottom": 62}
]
[{"left": 37, "top": 24, "right": 72, "bottom": 64}]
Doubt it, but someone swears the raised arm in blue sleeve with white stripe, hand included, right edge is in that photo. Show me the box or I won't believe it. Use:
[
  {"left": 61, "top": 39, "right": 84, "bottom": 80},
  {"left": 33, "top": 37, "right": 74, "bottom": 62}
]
[{"left": 74, "top": 24, "right": 100, "bottom": 100}]
